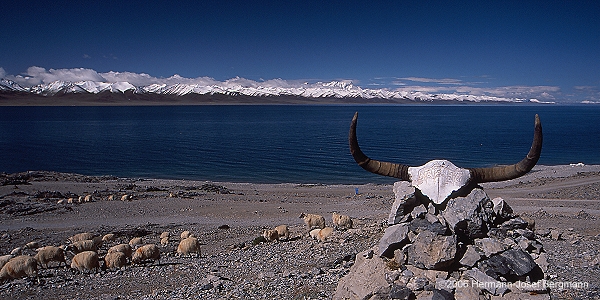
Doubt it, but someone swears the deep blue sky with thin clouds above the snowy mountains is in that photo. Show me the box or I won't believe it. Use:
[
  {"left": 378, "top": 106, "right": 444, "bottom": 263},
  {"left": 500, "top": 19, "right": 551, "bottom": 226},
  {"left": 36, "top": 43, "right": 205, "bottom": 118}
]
[{"left": 0, "top": 0, "right": 600, "bottom": 102}]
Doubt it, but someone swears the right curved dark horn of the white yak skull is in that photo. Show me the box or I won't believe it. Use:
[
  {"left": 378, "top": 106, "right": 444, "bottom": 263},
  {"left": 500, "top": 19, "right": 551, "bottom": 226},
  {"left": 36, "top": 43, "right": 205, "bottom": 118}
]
[{"left": 469, "top": 114, "right": 543, "bottom": 183}]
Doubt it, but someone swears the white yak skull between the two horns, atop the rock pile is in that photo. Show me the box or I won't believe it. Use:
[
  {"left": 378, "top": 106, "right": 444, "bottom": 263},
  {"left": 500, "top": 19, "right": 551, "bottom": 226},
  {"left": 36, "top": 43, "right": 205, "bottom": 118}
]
[{"left": 408, "top": 160, "right": 471, "bottom": 204}]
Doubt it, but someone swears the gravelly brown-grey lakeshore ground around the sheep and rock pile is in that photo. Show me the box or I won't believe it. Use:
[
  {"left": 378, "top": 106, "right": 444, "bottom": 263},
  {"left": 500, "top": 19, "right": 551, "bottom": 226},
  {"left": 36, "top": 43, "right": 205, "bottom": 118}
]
[{"left": 0, "top": 164, "right": 600, "bottom": 299}]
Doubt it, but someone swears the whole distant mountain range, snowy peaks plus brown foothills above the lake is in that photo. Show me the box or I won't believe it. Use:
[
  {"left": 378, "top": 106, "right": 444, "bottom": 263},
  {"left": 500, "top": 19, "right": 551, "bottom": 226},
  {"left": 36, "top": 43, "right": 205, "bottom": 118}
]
[{"left": 0, "top": 79, "right": 535, "bottom": 103}]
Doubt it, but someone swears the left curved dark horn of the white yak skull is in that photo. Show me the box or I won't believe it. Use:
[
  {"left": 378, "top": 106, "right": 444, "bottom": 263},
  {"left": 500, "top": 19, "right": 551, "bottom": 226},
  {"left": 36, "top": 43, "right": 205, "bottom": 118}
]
[{"left": 348, "top": 112, "right": 410, "bottom": 181}]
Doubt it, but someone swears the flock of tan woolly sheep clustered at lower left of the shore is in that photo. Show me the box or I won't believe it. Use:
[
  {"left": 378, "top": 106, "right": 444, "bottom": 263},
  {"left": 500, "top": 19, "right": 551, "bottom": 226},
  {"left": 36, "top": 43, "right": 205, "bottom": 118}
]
[{"left": 0, "top": 231, "right": 200, "bottom": 282}]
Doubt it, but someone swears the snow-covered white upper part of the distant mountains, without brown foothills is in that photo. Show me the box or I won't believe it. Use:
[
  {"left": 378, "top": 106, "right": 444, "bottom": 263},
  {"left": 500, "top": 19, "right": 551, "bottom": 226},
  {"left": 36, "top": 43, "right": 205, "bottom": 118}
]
[{"left": 0, "top": 79, "right": 525, "bottom": 102}]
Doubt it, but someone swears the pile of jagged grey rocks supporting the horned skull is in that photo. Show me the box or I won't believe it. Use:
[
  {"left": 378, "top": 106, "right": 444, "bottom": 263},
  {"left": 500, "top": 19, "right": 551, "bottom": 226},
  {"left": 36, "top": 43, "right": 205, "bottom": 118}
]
[{"left": 334, "top": 182, "right": 550, "bottom": 299}]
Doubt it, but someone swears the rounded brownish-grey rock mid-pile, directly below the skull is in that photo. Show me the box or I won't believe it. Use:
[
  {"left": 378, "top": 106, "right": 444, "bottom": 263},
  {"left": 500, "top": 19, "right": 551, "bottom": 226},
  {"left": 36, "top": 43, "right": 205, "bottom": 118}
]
[{"left": 407, "top": 230, "right": 456, "bottom": 270}]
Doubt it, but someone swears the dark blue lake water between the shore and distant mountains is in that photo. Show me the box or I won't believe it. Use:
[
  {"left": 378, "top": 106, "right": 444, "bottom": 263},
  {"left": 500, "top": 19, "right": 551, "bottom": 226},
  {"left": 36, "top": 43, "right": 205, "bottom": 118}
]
[{"left": 0, "top": 105, "right": 600, "bottom": 184}]
